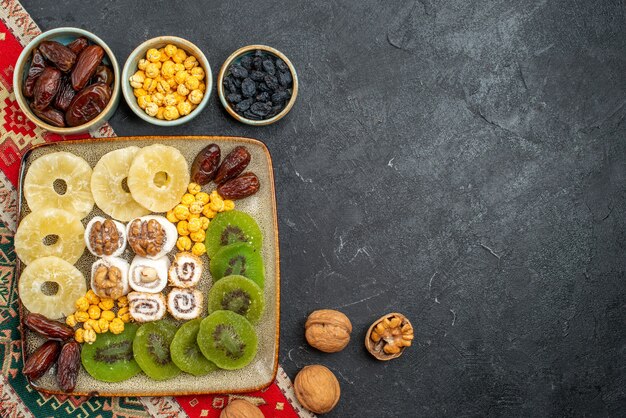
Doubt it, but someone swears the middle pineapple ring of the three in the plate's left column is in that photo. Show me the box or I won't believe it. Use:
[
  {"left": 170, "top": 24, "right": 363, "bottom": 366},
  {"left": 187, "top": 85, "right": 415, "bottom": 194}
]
[{"left": 15, "top": 208, "right": 85, "bottom": 264}]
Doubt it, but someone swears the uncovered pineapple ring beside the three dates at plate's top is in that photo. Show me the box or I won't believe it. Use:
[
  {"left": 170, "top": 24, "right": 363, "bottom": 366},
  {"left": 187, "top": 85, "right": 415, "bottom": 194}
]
[{"left": 127, "top": 144, "right": 189, "bottom": 216}]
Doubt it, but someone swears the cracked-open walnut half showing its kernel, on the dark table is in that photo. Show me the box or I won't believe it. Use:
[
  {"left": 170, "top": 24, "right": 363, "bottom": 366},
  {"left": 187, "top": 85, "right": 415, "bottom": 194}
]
[{"left": 365, "top": 313, "right": 414, "bottom": 361}]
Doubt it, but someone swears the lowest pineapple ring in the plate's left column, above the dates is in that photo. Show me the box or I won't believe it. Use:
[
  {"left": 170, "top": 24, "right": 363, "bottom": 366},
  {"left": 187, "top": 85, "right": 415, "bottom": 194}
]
[{"left": 18, "top": 257, "right": 87, "bottom": 319}]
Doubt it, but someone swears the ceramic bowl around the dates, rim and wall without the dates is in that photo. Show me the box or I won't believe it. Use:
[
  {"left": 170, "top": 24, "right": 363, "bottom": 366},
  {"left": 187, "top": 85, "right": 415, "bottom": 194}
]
[{"left": 13, "top": 27, "right": 120, "bottom": 135}]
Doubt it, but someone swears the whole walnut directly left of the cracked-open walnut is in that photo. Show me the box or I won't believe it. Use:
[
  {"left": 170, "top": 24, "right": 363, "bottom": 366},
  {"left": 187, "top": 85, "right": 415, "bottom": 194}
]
[{"left": 304, "top": 309, "right": 352, "bottom": 353}]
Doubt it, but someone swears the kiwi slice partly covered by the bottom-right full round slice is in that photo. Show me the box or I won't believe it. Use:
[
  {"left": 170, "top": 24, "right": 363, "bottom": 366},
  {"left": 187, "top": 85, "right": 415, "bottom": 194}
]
[{"left": 170, "top": 318, "right": 217, "bottom": 376}]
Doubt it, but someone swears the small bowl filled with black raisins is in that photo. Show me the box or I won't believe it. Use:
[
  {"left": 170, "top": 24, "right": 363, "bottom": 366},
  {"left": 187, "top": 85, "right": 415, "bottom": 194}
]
[{"left": 217, "top": 45, "right": 298, "bottom": 126}]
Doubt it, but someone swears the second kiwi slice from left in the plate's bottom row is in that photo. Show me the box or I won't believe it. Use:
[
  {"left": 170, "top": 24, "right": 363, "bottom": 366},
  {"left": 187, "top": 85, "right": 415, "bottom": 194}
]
[{"left": 133, "top": 321, "right": 180, "bottom": 380}]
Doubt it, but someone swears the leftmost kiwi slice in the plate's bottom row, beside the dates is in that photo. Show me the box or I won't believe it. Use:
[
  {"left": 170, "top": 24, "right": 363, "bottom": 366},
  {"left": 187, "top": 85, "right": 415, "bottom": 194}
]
[{"left": 80, "top": 324, "right": 141, "bottom": 383}]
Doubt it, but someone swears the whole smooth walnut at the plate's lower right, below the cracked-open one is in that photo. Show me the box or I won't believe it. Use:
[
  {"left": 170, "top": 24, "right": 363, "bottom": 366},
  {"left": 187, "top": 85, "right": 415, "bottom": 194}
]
[{"left": 293, "top": 364, "right": 341, "bottom": 414}]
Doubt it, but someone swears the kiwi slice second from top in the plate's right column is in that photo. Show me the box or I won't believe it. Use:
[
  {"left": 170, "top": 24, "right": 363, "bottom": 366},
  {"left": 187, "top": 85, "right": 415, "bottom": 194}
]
[{"left": 209, "top": 242, "right": 265, "bottom": 288}]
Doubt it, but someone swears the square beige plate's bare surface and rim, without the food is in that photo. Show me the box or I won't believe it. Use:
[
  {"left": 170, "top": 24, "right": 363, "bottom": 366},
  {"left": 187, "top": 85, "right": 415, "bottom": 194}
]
[{"left": 17, "top": 136, "right": 280, "bottom": 396}]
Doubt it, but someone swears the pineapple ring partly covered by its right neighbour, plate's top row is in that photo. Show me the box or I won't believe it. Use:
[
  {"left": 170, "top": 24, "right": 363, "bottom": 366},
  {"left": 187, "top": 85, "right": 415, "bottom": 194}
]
[{"left": 91, "top": 146, "right": 150, "bottom": 222}]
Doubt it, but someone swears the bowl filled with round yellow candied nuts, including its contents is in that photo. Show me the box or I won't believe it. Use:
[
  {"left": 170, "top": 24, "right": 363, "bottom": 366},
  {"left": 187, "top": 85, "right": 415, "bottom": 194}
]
[{"left": 122, "top": 36, "right": 213, "bottom": 126}]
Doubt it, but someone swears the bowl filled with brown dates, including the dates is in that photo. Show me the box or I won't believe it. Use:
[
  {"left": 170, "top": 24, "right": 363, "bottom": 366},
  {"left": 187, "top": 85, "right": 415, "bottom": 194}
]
[{"left": 13, "top": 28, "right": 120, "bottom": 135}]
